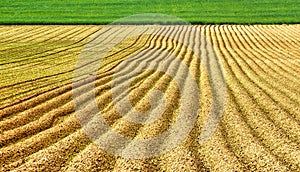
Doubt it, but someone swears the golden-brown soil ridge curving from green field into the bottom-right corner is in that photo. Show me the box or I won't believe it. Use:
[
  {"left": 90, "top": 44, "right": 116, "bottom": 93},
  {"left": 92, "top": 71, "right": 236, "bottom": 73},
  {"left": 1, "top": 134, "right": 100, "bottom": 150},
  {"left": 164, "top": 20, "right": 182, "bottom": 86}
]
[{"left": 212, "top": 25, "right": 299, "bottom": 169}]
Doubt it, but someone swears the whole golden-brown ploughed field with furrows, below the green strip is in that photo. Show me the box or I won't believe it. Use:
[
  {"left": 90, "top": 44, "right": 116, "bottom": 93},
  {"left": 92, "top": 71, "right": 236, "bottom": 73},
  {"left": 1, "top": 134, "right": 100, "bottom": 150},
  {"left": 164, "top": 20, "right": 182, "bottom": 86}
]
[{"left": 0, "top": 25, "right": 300, "bottom": 172}]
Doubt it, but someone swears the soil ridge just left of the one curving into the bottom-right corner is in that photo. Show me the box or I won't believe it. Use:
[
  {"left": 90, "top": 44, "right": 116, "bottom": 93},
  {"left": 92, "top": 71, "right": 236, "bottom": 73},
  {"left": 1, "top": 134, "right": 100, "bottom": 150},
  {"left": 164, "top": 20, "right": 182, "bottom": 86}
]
[{"left": 207, "top": 25, "right": 290, "bottom": 169}]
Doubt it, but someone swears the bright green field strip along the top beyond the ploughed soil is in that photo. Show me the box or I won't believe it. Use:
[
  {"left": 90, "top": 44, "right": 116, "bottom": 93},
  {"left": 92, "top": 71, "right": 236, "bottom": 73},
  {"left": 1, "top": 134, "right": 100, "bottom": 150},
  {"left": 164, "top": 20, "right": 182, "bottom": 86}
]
[{"left": 0, "top": 0, "right": 300, "bottom": 24}]
